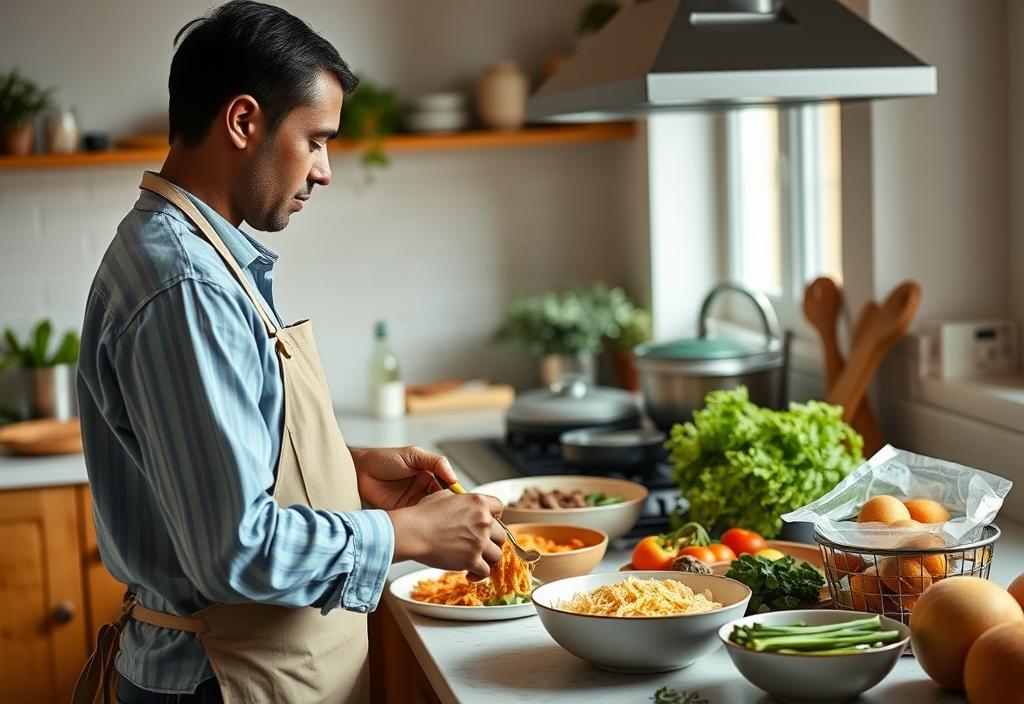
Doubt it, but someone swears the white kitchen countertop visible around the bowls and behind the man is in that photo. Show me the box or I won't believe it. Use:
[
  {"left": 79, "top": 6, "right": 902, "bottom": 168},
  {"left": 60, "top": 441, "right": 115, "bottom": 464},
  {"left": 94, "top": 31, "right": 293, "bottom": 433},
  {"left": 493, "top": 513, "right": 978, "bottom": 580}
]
[{"left": 0, "top": 411, "right": 1024, "bottom": 704}]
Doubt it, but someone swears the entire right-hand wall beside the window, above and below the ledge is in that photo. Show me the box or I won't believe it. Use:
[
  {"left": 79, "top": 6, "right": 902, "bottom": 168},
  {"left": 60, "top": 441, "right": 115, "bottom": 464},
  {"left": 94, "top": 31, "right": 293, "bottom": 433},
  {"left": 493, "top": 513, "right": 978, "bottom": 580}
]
[{"left": 843, "top": 0, "right": 1024, "bottom": 518}]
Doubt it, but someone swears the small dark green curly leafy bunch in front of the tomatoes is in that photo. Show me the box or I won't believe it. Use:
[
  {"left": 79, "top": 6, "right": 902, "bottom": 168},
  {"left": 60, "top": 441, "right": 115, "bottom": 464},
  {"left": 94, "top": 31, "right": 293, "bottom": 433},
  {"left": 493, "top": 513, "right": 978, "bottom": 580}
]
[{"left": 725, "top": 555, "right": 825, "bottom": 614}]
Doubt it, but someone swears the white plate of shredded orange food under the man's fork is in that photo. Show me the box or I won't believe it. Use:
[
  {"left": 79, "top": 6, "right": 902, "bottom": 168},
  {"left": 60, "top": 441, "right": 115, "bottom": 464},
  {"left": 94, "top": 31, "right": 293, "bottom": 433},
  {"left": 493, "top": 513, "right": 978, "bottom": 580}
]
[{"left": 391, "top": 542, "right": 539, "bottom": 621}]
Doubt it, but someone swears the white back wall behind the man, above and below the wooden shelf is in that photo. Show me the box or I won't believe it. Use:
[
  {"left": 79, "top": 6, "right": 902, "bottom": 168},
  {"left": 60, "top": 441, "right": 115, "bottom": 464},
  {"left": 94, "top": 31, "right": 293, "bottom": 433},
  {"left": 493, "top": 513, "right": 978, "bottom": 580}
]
[{"left": 0, "top": 0, "right": 649, "bottom": 406}]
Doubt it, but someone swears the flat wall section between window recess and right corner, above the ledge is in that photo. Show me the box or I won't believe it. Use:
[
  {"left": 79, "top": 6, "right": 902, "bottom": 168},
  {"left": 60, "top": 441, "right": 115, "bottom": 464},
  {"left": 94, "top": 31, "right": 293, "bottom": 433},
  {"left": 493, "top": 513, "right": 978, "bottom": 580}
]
[{"left": 870, "top": 0, "right": 1010, "bottom": 321}]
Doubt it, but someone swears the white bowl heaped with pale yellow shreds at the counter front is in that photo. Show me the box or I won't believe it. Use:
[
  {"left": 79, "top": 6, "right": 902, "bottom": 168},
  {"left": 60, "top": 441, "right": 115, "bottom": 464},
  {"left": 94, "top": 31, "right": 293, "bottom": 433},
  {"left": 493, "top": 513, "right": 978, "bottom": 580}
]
[{"left": 534, "top": 572, "right": 751, "bottom": 672}]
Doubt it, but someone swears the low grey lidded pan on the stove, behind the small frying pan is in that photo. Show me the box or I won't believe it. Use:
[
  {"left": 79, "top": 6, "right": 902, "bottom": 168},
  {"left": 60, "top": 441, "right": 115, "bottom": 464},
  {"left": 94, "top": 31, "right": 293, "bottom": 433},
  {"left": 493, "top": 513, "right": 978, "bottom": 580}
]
[{"left": 505, "top": 375, "right": 640, "bottom": 447}]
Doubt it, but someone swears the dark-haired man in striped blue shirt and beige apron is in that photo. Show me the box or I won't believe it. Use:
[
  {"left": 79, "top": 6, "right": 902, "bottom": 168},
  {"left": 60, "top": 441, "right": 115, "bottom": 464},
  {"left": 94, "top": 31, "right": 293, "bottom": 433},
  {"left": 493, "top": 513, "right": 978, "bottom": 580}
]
[{"left": 77, "top": 0, "right": 504, "bottom": 704}]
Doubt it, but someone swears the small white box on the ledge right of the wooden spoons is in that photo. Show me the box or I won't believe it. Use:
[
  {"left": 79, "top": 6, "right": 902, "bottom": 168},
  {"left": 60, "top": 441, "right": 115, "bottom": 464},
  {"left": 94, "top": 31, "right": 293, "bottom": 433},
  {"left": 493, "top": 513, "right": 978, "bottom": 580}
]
[{"left": 924, "top": 318, "right": 1017, "bottom": 380}]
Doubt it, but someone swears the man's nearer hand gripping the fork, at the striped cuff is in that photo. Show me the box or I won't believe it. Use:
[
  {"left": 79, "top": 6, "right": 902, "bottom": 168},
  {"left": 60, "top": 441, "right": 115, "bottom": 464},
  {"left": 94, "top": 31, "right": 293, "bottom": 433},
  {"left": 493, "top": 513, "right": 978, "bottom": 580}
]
[{"left": 388, "top": 491, "right": 505, "bottom": 581}]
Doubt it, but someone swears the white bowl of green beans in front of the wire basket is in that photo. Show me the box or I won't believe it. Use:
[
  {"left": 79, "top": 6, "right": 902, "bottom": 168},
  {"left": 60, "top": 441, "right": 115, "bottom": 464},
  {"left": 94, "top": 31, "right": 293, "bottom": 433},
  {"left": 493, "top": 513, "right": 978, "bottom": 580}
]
[{"left": 718, "top": 609, "right": 910, "bottom": 704}]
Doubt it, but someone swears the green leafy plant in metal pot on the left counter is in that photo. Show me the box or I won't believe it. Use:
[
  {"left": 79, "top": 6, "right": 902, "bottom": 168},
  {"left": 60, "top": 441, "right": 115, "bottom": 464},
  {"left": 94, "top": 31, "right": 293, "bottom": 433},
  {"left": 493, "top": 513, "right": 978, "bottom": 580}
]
[{"left": 0, "top": 320, "right": 79, "bottom": 421}]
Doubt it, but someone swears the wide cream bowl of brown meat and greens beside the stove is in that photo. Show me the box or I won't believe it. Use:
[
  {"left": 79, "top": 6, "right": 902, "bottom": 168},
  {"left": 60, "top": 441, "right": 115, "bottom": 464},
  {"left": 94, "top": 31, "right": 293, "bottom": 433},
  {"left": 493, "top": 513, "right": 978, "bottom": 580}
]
[{"left": 473, "top": 475, "right": 647, "bottom": 540}]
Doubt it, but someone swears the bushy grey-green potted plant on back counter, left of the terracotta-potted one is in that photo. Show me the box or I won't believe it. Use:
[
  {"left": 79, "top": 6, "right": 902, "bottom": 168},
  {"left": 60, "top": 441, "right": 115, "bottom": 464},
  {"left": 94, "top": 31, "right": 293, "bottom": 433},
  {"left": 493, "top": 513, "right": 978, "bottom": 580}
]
[{"left": 495, "top": 283, "right": 625, "bottom": 384}]
